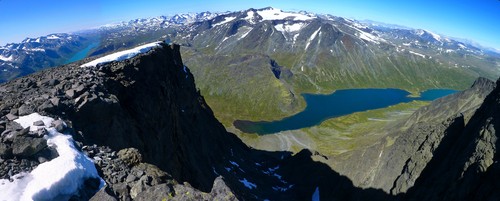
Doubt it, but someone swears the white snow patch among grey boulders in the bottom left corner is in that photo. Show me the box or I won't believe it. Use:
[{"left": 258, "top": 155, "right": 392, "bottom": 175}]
[{"left": 0, "top": 113, "right": 105, "bottom": 201}]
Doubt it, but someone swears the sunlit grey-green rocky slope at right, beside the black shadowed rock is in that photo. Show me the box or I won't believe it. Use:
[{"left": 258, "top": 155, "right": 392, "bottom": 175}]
[{"left": 335, "top": 75, "right": 495, "bottom": 195}]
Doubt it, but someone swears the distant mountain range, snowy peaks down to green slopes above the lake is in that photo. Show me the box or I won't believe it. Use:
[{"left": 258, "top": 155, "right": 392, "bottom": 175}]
[{"left": 0, "top": 8, "right": 500, "bottom": 126}]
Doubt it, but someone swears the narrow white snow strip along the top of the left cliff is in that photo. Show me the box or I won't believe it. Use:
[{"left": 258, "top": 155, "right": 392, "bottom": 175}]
[{"left": 80, "top": 42, "right": 161, "bottom": 67}]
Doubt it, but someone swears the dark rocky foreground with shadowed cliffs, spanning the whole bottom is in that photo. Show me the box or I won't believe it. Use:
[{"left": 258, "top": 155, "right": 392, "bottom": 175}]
[{"left": 0, "top": 44, "right": 500, "bottom": 200}]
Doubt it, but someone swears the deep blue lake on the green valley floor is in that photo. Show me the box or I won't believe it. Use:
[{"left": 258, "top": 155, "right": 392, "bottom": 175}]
[{"left": 233, "top": 89, "right": 457, "bottom": 135}]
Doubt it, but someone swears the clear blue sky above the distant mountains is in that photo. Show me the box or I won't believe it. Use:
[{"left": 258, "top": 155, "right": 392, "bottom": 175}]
[{"left": 0, "top": 0, "right": 500, "bottom": 50}]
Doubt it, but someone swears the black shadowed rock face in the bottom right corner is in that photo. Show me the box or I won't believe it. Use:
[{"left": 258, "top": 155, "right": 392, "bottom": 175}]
[{"left": 406, "top": 77, "right": 500, "bottom": 200}]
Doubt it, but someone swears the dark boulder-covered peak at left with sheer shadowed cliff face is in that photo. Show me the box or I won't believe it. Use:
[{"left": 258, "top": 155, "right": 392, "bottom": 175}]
[{"left": 0, "top": 45, "right": 248, "bottom": 200}]
